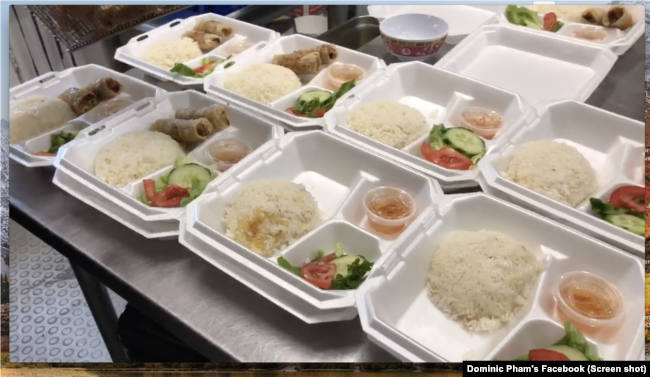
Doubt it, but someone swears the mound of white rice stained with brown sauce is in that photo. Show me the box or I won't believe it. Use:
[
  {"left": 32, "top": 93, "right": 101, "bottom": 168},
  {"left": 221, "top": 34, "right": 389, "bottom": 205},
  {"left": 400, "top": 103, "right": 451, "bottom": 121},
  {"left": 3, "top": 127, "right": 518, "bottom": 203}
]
[{"left": 223, "top": 179, "right": 321, "bottom": 257}]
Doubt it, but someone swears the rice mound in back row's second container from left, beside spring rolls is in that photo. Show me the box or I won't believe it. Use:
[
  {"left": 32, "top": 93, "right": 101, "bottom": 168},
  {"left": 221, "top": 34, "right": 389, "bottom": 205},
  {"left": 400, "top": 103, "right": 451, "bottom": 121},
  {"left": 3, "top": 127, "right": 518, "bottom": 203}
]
[{"left": 224, "top": 64, "right": 302, "bottom": 104}]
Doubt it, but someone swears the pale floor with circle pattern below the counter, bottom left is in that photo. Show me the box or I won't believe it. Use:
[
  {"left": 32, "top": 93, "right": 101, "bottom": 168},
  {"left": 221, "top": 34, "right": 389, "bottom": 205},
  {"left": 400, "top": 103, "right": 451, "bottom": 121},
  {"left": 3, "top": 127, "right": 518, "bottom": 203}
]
[{"left": 9, "top": 221, "right": 126, "bottom": 363}]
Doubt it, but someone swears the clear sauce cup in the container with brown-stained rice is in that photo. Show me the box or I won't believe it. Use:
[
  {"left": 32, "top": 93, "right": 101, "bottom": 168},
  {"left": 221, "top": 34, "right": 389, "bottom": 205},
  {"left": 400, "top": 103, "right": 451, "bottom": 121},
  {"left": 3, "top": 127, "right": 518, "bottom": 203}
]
[{"left": 363, "top": 187, "right": 416, "bottom": 235}]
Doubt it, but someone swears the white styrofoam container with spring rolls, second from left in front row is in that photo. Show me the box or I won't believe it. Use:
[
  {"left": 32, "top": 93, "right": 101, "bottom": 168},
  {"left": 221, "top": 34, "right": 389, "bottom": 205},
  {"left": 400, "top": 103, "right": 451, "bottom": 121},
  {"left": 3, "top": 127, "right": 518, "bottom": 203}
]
[{"left": 50, "top": 90, "right": 284, "bottom": 238}]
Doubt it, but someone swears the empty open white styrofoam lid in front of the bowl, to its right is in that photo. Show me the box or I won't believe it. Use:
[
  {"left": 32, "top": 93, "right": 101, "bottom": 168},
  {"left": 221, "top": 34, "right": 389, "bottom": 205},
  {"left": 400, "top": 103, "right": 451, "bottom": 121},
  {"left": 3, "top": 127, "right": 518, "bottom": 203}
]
[{"left": 435, "top": 24, "right": 618, "bottom": 106}]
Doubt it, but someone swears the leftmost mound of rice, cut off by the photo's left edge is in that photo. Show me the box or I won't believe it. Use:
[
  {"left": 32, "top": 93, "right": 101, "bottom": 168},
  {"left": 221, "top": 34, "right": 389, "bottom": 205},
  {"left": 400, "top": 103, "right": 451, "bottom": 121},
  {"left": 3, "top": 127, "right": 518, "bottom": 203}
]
[{"left": 9, "top": 96, "right": 77, "bottom": 144}]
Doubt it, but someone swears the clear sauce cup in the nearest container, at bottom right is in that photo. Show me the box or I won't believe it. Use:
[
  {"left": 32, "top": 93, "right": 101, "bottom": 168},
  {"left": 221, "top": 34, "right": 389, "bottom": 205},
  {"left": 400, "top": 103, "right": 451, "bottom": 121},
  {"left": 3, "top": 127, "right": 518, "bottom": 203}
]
[{"left": 553, "top": 271, "right": 624, "bottom": 330}]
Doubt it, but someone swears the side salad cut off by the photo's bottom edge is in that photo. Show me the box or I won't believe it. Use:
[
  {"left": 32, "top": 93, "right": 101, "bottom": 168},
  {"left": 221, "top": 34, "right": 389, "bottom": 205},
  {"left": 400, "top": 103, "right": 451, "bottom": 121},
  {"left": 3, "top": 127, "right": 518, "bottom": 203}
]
[{"left": 495, "top": 321, "right": 603, "bottom": 361}]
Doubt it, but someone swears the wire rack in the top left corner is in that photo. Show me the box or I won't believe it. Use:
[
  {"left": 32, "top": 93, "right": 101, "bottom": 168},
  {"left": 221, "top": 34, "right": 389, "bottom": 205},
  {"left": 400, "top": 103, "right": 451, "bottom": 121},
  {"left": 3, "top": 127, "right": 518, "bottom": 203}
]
[{"left": 27, "top": 5, "right": 190, "bottom": 52}]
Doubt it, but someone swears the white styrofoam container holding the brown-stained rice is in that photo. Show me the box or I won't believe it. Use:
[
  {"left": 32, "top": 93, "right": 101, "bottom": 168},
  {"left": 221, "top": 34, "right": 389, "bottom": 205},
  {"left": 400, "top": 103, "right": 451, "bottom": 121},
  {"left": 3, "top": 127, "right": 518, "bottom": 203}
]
[{"left": 181, "top": 131, "right": 443, "bottom": 323}]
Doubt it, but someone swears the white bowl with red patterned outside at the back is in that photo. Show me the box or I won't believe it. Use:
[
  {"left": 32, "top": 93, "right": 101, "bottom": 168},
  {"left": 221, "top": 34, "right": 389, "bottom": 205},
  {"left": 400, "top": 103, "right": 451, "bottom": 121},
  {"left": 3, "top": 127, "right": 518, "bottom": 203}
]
[{"left": 379, "top": 13, "right": 449, "bottom": 61}]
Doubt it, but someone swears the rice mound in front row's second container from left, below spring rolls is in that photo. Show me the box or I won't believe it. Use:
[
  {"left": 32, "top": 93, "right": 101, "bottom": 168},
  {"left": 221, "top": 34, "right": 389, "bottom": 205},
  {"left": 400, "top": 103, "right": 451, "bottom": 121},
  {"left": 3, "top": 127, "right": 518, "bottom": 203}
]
[{"left": 95, "top": 131, "right": 185, "bottom": 187}]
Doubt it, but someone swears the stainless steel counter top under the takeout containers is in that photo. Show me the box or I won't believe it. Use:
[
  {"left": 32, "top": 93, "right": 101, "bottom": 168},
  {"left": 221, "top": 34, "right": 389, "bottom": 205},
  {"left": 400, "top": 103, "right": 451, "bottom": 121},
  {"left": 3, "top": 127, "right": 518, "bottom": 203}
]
[{"left": 10, "top": 18, "right": 644, "bottom": 362}]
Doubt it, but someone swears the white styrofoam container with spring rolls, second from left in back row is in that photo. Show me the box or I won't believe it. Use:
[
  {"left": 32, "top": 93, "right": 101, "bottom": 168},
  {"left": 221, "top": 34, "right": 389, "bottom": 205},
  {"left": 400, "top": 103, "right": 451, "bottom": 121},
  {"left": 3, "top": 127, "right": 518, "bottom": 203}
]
[{"left": 204, "top": 34, "right": 386, "bottom": 131}]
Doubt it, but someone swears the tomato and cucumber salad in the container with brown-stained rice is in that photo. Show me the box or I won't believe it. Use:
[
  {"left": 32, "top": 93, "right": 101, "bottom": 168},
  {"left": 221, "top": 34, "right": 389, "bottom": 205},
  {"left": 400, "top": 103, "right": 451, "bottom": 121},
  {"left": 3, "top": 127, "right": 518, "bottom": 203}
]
[{"left": 278, "top": 244, "right": 374, "bottom": 290}]
